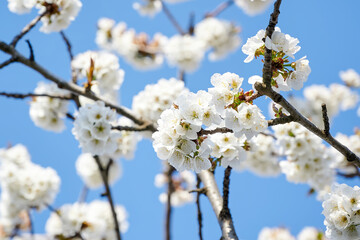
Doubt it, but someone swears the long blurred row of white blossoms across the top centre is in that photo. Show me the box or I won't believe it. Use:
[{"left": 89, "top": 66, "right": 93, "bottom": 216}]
[{"left": 96, "top": 17, "right": 240, "bottom": 72}]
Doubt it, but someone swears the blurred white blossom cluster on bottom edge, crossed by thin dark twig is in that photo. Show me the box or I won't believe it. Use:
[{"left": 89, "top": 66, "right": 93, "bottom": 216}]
[{"left": 46, "top": 200, "right": 129, "bottom": 240}]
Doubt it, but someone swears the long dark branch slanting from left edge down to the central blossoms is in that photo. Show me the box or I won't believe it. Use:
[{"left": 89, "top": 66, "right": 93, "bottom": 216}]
[{"left": 0, "top": 41, "right": 156, "bottom": 131}]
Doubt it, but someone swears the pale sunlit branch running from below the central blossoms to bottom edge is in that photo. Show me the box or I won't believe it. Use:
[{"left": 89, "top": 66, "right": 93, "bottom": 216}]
[{"left": 199, "top": 170, "right": 238, "bottom": 240}]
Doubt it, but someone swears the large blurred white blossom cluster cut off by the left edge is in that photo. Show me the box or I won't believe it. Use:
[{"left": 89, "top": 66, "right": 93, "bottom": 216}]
[{"left": 0, "top": 144, "right": 60, "bottom": 237}]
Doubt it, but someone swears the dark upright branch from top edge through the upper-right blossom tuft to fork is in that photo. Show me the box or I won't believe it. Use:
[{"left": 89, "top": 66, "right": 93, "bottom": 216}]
[{"left": 263, "top": 0, "right": 281, "bottom": 87}]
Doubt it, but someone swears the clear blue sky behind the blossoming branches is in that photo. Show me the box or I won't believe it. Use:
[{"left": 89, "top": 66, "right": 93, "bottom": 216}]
[{"left": 0, "top": 0, "right": 360, "bottom": 240}]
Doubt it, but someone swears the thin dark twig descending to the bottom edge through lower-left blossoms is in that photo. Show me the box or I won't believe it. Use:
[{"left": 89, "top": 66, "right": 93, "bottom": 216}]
[{"left": 94, "top": 156, "right": 121, "bottom": 240}]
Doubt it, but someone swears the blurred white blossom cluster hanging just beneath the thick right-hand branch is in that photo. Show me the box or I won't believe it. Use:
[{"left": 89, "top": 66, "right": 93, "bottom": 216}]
[{"left": 273, "top": 122, "right": 335, "bottom": 195}]
